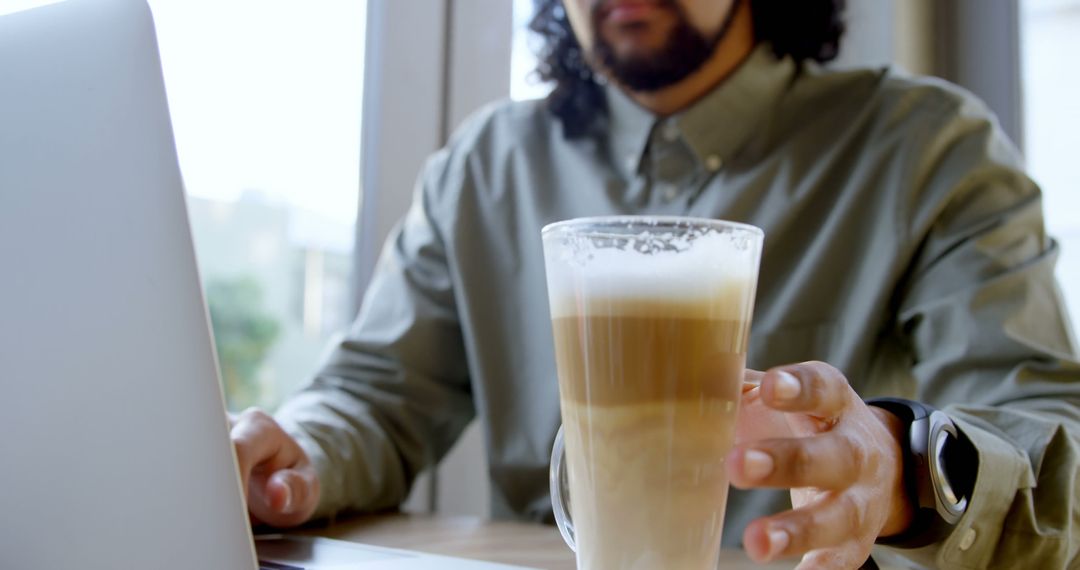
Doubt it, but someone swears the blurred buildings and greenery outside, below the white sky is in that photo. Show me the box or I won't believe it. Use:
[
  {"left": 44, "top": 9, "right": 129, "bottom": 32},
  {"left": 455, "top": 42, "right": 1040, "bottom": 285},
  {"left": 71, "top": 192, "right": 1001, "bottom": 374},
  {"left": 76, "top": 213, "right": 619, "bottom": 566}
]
[{"left": 188, "top": 196, "right": 353, "bottom": 411}]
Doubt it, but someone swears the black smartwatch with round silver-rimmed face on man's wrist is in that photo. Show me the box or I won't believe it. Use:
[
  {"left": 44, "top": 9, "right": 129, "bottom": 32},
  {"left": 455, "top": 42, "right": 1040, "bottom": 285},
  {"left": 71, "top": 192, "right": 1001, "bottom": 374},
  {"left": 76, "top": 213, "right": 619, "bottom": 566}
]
[{"left": 866, "top": 398, "right": 978, "bottom": 548}]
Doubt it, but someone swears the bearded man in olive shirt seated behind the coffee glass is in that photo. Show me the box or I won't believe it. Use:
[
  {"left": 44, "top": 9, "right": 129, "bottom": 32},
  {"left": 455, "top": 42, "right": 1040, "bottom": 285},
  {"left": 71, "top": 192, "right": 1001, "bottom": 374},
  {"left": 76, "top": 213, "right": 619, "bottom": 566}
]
[{"left": 233, "top": 0, "right": 1080, "bottom": 568}]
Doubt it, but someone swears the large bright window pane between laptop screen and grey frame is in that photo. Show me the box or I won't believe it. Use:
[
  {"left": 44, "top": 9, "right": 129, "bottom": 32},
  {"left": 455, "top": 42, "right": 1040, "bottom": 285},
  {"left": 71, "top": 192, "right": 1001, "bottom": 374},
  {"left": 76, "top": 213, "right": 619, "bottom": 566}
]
[{"left": 150, "top": 0, "right": 366, "bottom": 410}]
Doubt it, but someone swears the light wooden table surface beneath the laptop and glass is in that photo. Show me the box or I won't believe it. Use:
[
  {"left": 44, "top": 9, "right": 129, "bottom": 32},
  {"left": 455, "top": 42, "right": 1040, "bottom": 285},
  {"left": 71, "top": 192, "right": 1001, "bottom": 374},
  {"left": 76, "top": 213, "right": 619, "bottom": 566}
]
[{"left": 293, "top": 514, "right": 795, "bottom": 570}]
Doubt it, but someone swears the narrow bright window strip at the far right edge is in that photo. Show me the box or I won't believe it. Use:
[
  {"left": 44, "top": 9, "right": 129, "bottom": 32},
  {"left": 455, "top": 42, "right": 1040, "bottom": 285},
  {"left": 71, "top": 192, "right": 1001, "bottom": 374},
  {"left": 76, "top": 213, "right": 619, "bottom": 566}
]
[{"left": 1021, "top": 0, "right": 1080, "bottom": 331}]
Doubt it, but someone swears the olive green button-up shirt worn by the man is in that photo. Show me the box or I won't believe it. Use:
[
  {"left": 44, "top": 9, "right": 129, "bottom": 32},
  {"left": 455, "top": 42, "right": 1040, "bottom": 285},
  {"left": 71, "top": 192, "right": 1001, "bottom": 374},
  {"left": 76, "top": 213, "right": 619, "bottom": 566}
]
[{"left": 279, "top": 46, "right": 1080, "bottom": 568}]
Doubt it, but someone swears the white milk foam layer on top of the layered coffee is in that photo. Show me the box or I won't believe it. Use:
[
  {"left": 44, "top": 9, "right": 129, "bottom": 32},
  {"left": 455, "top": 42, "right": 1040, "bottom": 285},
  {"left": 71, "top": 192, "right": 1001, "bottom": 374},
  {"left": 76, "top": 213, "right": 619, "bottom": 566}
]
[{"left": 546, "top": 233, "right": 757, "bottom": 321}]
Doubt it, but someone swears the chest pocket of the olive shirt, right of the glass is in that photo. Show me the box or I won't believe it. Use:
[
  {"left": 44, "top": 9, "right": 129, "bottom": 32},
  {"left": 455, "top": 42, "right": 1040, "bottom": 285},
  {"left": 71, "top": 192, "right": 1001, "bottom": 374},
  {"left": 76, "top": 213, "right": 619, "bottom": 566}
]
[{"left": 746, "top": 321, "right": 840, "bottom": 370}]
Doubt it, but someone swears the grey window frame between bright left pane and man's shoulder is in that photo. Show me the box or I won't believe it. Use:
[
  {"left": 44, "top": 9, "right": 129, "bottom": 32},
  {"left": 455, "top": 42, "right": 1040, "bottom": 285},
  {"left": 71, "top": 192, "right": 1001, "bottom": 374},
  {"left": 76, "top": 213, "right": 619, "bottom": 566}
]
[{"left": 351, "top": 0, "right": 513, "bottom": 516}]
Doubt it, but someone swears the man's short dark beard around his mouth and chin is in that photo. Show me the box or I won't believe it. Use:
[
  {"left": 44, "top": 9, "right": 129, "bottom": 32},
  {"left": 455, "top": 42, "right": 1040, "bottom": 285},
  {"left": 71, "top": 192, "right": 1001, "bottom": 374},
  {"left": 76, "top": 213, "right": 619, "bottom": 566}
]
[{"left": 592, "top": 0, "right": 739, "bottom": 92}]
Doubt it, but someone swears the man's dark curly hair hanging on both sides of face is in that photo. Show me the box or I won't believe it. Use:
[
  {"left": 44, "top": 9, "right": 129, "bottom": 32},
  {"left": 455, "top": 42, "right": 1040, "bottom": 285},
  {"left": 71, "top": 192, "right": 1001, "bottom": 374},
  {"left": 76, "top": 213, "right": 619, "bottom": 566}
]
[{"left": 529, "top": 0, "right": 847, "bottom": 138}]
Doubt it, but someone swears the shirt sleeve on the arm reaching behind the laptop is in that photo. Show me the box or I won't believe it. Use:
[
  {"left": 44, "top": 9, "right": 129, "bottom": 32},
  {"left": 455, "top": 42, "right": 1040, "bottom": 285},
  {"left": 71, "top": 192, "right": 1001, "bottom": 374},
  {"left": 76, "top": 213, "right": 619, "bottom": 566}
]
[{"left": 276, "top": 150, "right": 475, "bottom": 517}]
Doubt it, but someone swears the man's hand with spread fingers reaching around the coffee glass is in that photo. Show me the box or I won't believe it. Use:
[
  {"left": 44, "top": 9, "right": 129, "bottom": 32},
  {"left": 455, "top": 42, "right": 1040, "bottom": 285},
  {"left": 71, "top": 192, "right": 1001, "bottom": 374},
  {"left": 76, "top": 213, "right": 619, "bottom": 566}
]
[{"left": 727, "top": 363, "right": 912, "bottom": 570}]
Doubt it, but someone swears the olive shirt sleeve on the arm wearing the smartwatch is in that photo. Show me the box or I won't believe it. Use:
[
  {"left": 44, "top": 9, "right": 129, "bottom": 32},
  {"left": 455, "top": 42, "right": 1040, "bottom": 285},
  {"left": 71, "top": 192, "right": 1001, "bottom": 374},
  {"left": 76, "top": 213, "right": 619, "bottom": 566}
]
[{"left": 896, "top": 94, "right": 1080, "bottom": 569}]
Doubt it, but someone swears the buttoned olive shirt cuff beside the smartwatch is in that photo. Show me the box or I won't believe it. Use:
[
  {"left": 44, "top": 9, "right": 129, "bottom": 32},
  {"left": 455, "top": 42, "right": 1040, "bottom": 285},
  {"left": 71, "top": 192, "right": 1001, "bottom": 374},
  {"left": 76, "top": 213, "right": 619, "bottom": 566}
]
[{"left": 888, "top": 410, "right": 1029, "bottom": 569}]
